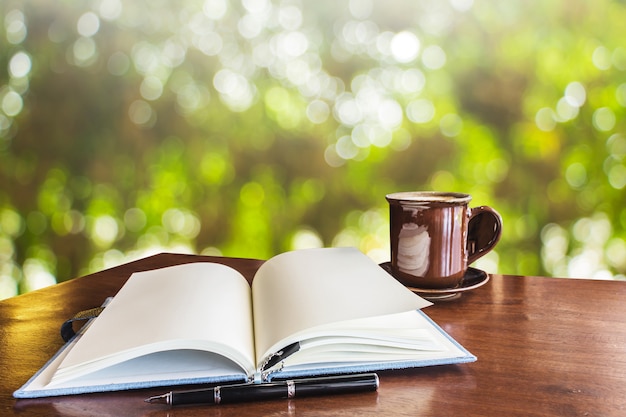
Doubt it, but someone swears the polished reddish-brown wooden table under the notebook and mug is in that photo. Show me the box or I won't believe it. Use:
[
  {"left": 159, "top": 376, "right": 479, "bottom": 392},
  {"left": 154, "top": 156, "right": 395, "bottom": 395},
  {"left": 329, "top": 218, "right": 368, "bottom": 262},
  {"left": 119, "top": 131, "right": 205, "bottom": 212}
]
[{"left": 0, "top": 254, "right": 626, "bottom": 417}]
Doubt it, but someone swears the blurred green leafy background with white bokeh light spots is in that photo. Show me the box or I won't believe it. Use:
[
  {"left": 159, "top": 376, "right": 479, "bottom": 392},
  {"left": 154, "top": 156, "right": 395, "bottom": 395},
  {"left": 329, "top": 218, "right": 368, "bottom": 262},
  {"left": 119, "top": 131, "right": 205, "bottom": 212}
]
[{"left": 0, "top": 0, "right": 626, "bottom": 298}]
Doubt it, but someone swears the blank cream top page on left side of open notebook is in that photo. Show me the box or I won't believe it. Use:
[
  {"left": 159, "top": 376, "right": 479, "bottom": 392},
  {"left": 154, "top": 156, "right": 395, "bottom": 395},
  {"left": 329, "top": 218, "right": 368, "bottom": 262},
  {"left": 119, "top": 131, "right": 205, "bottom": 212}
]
[{"left": 53, "top": 263, "right": 254, "bottom": 382}]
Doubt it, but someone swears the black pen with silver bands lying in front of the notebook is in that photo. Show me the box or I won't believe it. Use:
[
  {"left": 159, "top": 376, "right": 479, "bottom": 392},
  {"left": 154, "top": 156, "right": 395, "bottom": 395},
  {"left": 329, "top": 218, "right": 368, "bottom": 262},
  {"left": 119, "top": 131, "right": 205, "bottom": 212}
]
[{"left": 145, "top": 373, "right": 378, "bottom": 405}]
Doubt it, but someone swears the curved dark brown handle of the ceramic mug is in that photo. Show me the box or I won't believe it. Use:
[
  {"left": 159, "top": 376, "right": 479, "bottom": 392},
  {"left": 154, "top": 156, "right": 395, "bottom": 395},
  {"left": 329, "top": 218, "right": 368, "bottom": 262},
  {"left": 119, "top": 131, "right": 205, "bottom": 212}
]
[{"left": 467, "top": 206, "right": 502, "bottom": 265}]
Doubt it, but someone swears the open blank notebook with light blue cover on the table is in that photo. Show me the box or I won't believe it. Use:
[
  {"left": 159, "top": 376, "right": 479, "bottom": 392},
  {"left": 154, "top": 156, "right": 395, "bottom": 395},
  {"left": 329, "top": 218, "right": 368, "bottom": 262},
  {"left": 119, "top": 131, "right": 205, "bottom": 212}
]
[{"left": 14, "top": 248, "right": 476, "bottom": 398}]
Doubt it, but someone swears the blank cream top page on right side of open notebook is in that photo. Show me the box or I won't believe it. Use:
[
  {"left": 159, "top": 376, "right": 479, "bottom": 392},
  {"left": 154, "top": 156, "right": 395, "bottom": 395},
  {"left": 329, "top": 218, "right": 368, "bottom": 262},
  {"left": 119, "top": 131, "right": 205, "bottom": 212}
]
[{"left": 252, "top": 248, "right": 431, "bottom": 362}]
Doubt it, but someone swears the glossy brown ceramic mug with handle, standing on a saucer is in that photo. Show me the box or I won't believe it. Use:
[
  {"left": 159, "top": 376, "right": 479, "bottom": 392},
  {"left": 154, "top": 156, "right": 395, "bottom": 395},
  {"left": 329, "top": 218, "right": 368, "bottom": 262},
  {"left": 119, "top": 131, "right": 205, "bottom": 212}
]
[{"left": 386, "top": 191, "right": 502, "bottom": 289}]
